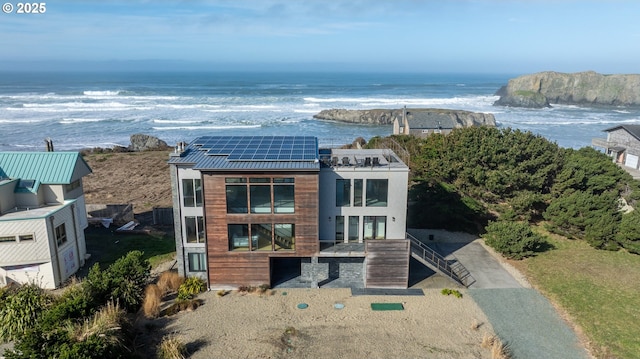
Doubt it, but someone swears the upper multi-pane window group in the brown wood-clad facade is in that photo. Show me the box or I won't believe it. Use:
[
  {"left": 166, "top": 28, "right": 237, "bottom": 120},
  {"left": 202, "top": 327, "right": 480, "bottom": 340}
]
[{"left": 225, "top": 177, "right": 295, "bottom": 214}]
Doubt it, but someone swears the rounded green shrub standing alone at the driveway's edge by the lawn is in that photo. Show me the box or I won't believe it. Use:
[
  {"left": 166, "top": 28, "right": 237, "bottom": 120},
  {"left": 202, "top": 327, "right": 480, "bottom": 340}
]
[{"left": 482, "top": 221, "right": 546, "bottom": 259}]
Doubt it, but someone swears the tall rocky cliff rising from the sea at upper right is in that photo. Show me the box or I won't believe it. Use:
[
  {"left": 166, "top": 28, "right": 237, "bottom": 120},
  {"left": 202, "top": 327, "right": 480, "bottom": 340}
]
[{"left": 494, "top": 71, "right": 640, "bottom": 108}]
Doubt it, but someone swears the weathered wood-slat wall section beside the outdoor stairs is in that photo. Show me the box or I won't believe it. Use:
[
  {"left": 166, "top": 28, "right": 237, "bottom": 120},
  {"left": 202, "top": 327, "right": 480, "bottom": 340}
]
[{"left": 365, "top": 239, "right": 410, "bottom": 288}]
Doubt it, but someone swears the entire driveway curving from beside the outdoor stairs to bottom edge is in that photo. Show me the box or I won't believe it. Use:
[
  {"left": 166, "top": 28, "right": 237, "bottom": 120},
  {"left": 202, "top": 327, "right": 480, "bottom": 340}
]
[{"left": 409, "top": 230, "right": 590, "bottom": 359}]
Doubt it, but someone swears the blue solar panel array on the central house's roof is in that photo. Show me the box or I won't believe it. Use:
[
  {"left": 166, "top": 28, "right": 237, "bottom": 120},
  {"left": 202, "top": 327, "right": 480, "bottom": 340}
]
[{"left": 192, "top": 136, "right": 318, "bottom": 161}]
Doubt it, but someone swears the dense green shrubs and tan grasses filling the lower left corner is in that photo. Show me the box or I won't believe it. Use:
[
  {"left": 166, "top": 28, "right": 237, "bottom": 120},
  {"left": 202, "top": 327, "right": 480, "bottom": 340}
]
[{"left": 0, "top": 251, "right": 150, "bottom": 359}]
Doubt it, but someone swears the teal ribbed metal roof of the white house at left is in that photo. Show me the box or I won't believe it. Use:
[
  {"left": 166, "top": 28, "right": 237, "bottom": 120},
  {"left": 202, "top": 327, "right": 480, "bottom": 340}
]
[{"left": 0, "top": 152, "right": 91, "bottom": 184}]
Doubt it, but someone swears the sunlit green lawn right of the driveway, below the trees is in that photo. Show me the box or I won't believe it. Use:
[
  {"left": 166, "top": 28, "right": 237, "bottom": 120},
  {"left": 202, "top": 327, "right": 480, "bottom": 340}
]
[{"left": 514, "top": 234, "right": 640, "bottom": 358}]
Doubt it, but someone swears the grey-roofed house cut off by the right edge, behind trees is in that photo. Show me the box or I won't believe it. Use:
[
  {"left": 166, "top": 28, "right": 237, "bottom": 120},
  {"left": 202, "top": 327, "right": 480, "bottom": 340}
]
[{"left": 591, "top": 125, "right": 640, "bottom": 170}]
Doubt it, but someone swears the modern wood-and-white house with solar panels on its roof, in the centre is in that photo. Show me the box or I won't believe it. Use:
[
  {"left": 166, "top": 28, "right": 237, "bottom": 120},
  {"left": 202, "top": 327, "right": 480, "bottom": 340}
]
[{"left": 169, "top": 136, "right": 410, "bottom": 288}]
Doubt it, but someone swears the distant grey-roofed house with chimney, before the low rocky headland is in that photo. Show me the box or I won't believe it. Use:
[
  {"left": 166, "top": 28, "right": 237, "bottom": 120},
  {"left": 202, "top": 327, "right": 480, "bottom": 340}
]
[{"left": 393, "top": 108, "right": 456, "bottom": 137}]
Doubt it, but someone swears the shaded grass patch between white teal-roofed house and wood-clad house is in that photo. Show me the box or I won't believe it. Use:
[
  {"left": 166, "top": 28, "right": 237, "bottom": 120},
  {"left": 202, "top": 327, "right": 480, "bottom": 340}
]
[{"left": 85, "top": 227, "right": 176, "bottom": 269}]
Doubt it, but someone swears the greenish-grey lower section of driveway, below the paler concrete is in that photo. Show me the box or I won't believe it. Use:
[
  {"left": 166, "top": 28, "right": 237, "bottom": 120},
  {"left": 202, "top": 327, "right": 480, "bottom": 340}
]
[{"left": 469, "top": 288, "right": 591, "bottom": 359}]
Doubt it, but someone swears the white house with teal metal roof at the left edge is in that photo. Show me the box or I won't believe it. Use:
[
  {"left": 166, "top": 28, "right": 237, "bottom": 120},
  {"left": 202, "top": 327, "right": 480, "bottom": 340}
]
[{"left": 0, "top": 152, "right": 91, "bottom": 289}]
